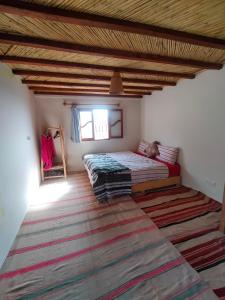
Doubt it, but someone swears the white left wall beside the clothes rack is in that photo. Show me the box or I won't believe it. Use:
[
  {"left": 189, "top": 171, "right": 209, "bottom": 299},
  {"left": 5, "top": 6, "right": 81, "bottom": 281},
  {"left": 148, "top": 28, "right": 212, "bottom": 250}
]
[{"left": 0, "top": 64, "right": 39, "bottom": 267}]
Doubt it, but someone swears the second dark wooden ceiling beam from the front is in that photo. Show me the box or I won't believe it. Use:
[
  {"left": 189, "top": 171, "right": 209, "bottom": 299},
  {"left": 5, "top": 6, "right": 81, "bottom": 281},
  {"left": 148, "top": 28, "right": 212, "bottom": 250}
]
[{"left": 0, "top": 32, "right": 223, "bottom": 69}]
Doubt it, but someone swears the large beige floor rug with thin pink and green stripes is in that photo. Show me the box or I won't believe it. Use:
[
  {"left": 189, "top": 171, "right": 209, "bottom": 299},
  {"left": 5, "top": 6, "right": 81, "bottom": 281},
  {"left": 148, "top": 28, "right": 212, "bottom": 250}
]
[{"left": 0, "top": 174, "right": 217, "bottom": 300}]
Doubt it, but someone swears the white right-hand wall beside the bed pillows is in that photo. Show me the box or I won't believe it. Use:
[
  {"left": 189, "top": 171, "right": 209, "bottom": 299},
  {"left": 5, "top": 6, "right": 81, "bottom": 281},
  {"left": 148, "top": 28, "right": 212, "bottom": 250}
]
[{"left": 142, "top": 68, "right": 225, "bottom": 201}]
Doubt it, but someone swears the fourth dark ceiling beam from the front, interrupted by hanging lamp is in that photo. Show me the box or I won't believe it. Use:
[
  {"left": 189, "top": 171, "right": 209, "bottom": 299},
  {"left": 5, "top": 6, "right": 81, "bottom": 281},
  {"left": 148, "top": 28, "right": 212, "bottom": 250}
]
[{"left": 12, "top": 69, "right": 176, "bottom": 86}]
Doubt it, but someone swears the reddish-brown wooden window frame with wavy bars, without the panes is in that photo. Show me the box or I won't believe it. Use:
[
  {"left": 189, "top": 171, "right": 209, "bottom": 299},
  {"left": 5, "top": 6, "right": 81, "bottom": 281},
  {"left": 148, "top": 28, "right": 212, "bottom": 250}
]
[{"left": 79, "top": 108, "right": 123, "bottom": 142}]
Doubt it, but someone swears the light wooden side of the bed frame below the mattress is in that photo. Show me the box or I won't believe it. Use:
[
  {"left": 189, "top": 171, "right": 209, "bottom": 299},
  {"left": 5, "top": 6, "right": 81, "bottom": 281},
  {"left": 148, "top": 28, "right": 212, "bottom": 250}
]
[{"left": 132, "top": 176, "right": 181, "bottom": 193}]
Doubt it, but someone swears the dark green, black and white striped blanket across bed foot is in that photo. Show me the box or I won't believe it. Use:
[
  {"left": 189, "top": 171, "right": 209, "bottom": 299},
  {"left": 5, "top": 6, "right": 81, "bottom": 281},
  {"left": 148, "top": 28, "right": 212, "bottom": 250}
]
[{"left": 84, "top": 153, "right": 131, "bottom": 201}]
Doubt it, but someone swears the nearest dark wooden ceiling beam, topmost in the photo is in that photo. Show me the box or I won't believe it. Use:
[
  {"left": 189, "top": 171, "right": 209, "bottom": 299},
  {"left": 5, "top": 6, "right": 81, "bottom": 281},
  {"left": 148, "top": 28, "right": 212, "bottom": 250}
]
[{"left": 0, "top": 0, "right": 225, "bottom": 49}]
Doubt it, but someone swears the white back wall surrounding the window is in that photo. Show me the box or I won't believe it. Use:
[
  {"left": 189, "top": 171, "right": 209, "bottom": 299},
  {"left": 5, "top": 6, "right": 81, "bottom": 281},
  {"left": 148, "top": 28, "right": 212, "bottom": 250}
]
[{"left": 36, "top": 96, "right": 141, "bottom": 171}]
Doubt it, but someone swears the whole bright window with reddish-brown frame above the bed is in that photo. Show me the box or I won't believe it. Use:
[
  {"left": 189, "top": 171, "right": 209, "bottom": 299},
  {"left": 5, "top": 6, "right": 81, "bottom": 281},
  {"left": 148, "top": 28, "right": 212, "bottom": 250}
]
[{"left": 80, "top": 109, "right": 123, "bottom": 141}]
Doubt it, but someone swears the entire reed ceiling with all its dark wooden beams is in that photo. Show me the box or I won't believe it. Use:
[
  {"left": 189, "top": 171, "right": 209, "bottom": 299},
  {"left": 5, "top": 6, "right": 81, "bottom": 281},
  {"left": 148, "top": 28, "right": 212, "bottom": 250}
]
[{"left": 0, "top": 0, "right": 225, "bottom": 98}]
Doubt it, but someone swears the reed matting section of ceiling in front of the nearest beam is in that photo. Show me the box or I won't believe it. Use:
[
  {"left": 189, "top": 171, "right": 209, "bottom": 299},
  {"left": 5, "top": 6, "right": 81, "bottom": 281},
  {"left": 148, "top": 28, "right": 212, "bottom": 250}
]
[{"left": 26, "top": 0, "right": 225, "bottom": 39}]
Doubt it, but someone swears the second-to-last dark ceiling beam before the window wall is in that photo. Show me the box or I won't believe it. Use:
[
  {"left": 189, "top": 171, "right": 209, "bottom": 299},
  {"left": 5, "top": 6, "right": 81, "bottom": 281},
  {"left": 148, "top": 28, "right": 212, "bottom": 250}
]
[{"left": 29, "top": 86, "right": 152, "bottom": 95}]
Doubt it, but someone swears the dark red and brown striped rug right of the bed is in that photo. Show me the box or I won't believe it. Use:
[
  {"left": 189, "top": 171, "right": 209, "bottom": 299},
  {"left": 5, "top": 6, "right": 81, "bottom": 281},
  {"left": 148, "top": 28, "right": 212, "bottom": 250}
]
[{"left": 133, "top": 187, "right": 225, "bottom": 299}]
